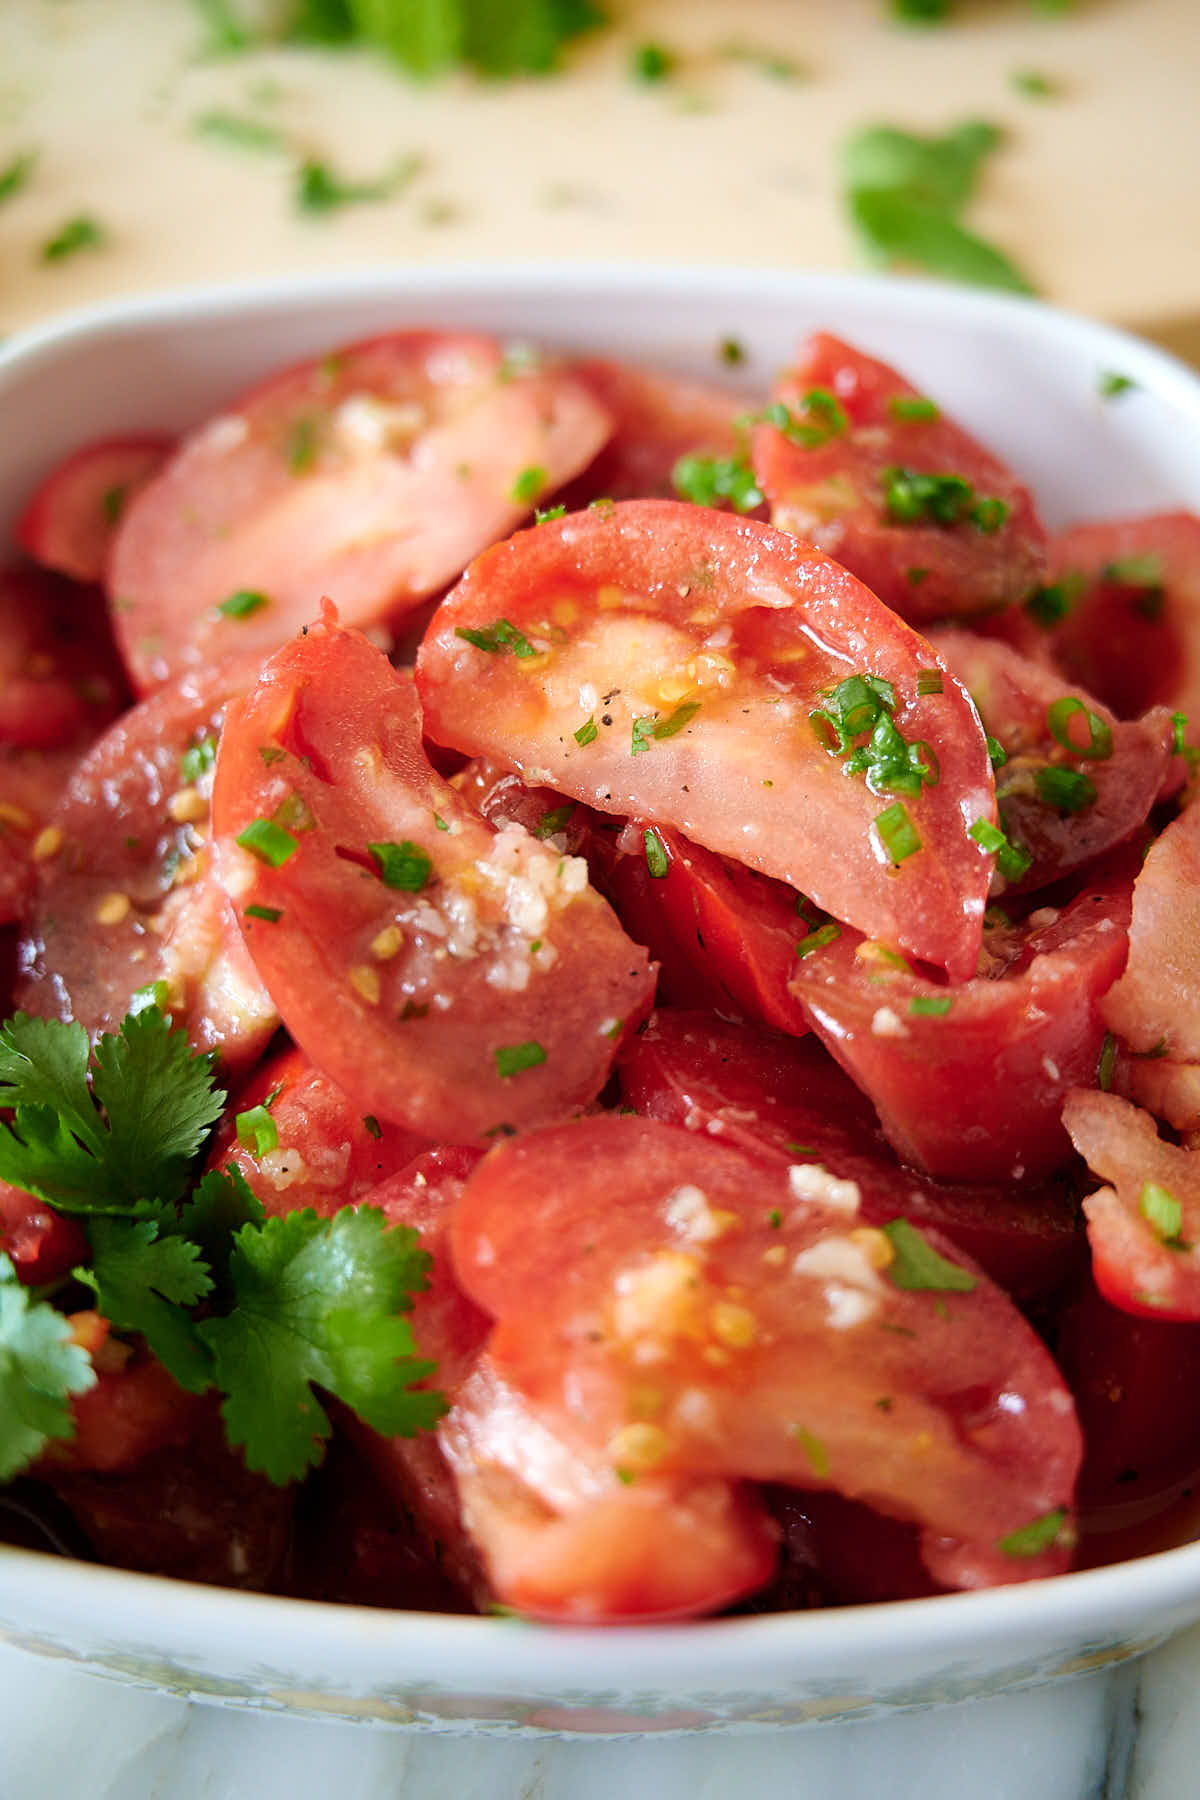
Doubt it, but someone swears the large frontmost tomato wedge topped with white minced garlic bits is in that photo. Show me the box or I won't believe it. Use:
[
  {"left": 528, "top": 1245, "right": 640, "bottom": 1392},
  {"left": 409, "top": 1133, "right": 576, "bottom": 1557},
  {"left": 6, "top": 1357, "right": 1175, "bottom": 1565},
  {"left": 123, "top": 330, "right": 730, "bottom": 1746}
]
[{"left": 452, "top": 1118, "right": 1081, "bottom": 1586}]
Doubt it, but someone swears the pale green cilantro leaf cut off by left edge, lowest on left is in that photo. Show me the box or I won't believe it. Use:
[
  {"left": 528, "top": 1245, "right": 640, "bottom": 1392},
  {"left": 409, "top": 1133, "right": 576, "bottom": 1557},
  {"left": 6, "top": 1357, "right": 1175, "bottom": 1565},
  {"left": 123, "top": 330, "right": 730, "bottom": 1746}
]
[{"left": 0, "top": 1255, "right": 95, "bottom": 1481}]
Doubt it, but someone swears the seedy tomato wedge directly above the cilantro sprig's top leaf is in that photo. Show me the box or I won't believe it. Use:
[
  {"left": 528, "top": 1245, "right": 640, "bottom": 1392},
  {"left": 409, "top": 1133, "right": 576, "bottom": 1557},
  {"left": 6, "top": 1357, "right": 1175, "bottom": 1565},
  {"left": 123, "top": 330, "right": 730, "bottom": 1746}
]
[{"left": 14, "top": 661, "right": 279, "bottom": 1075}]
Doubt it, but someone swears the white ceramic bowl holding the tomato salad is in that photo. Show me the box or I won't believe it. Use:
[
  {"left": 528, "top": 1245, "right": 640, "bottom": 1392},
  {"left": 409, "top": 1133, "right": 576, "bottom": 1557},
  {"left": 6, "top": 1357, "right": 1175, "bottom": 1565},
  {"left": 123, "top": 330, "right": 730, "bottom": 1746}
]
[{"left": 0, "top": 266, "right": 1200, "bottom": 1733}]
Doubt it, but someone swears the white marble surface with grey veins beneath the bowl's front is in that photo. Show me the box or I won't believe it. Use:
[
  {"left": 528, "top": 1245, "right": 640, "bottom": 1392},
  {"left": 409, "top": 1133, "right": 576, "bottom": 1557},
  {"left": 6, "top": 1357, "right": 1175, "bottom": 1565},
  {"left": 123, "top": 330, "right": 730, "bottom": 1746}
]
[{"left": 0, "top": 1629, "right": 1200, "bottom": 1800}]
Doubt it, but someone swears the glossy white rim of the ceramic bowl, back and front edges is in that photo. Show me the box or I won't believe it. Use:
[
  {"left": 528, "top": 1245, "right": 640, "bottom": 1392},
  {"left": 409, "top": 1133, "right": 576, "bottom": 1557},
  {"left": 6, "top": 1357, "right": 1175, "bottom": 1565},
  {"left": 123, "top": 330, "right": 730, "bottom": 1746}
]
[{"left": 0, "top": 261, "right": 1200, "bottom": 1694}]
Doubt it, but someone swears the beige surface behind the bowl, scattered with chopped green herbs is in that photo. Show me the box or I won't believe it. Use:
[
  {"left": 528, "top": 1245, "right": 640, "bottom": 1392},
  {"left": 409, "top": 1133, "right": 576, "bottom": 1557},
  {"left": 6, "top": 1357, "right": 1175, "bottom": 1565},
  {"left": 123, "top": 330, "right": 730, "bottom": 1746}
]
[{"left": 0, "top": 0, "right": 1200, "bottom": 355}]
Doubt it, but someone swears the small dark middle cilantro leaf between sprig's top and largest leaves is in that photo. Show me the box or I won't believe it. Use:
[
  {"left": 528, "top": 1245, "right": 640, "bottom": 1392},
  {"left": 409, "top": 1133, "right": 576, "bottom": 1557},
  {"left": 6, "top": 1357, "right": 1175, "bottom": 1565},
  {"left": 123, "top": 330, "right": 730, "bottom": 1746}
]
[{"left": 74, "top": 1219, "right": 212, "bottom": 1393}]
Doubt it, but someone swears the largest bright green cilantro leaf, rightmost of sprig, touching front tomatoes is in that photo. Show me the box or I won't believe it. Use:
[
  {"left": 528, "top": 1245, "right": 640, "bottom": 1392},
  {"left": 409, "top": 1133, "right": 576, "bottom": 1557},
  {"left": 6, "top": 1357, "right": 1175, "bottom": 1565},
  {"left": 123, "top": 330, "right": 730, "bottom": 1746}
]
[{"left": 198, "top": 1206, "right": 446, "bottom": 1485}]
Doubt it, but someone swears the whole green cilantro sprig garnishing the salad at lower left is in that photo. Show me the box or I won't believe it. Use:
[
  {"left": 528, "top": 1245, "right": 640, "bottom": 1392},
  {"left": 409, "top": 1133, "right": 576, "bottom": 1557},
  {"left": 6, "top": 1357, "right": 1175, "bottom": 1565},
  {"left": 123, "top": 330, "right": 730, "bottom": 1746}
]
[{"left": 0, "top": 1004, "right": 444, "bottom": 1485}]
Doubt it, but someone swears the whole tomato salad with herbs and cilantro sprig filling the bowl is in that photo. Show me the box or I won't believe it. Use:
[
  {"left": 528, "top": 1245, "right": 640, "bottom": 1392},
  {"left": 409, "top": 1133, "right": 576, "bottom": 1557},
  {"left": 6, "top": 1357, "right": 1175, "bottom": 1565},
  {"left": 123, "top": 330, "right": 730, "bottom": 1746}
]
[{"left": 0, "top": 329, "right": 1200, "bottom": 1622}]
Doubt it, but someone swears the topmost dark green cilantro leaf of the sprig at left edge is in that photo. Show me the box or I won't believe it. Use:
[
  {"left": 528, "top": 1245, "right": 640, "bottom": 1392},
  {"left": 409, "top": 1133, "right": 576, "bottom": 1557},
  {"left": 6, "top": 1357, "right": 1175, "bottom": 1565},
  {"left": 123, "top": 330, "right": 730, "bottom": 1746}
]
[{"left": 0, "top": 1006, "right": 225, "bottom": 1215}]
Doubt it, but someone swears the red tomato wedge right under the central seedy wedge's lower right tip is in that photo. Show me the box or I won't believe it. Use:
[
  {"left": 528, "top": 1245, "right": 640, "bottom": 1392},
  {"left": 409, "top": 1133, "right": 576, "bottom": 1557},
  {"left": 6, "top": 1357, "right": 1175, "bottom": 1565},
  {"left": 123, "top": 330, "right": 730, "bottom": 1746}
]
[{"left": 792, "top": 873, "right": 1130, "bottom": 1183}]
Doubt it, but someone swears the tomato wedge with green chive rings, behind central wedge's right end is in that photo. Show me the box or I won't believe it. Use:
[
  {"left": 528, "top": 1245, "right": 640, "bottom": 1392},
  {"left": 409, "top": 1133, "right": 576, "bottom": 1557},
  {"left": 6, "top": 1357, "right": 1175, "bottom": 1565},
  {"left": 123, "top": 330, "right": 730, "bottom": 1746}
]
[{"left": 930, "top": 628, "right": 1184, "bottom": 893}]
